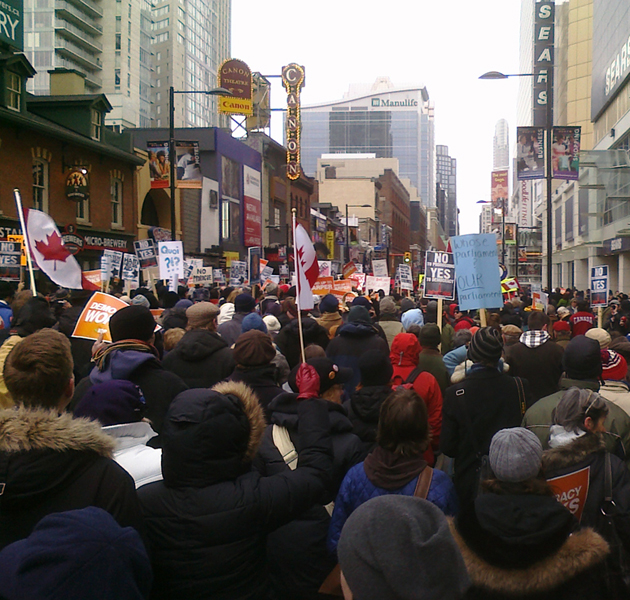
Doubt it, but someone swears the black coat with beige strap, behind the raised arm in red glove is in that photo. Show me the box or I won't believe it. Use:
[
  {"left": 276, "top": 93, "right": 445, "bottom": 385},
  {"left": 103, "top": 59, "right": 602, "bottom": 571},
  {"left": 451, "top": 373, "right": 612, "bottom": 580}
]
[{"left": 255, "top": 393, "right": 364, "bottom": 600}]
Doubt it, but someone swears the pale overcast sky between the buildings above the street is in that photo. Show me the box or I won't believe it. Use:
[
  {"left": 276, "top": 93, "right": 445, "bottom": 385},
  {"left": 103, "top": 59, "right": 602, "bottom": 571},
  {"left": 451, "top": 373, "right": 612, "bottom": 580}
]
[{"left": 232, "top": 0, "right": 521, "bottom": 233}]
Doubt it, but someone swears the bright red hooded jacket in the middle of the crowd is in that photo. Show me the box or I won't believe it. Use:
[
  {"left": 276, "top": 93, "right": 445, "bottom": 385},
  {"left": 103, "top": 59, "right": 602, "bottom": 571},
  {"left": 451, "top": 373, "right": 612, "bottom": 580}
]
[{"left": 389, "top": 333, "right": 442, "bottom": 465}]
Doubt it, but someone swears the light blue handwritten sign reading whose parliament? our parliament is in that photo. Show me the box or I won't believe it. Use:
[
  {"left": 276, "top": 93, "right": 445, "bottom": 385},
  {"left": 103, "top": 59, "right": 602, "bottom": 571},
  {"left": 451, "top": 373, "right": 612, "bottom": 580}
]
[{"left": 451, "top": 233, "right": 503, "bottom": 310}]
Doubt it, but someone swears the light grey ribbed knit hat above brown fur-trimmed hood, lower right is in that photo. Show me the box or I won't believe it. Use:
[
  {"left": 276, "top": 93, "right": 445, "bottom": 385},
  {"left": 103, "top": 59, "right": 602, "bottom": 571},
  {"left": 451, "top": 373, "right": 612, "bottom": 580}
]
[{"left": 490, "top": 427, "right": 543, "bottom": 483}]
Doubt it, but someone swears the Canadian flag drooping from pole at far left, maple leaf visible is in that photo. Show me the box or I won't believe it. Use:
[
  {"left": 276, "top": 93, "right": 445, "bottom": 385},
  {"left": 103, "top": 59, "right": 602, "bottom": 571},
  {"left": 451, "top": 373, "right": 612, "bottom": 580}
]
[{"left": 26, "top": 209, "right": 99, "bottom": 290}]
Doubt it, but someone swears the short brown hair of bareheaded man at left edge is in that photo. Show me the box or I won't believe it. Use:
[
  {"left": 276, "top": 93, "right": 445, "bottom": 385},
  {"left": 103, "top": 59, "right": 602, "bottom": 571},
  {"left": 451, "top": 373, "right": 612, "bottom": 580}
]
[{"left": 4, "top": 329, "right": 74, "bottom": 408}]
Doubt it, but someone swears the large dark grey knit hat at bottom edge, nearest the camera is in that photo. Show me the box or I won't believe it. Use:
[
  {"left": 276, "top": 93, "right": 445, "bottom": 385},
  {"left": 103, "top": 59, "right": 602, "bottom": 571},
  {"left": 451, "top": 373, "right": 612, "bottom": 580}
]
[{"left": 337, "top": 494, "right": 470, "bottom": 600}]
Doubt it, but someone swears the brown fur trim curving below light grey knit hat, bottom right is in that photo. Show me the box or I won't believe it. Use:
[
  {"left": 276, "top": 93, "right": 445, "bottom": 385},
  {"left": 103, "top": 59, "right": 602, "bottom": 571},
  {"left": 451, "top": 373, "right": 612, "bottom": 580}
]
[{"left": 449, "top": 519, "right": 610, "bottom": 596}]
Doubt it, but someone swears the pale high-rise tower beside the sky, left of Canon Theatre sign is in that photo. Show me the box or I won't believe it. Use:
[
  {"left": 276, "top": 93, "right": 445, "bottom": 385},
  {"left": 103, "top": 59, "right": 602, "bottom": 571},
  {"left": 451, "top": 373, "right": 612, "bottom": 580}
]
[{"left": 153, "top": 0, "right": 231, "bottom": 127}]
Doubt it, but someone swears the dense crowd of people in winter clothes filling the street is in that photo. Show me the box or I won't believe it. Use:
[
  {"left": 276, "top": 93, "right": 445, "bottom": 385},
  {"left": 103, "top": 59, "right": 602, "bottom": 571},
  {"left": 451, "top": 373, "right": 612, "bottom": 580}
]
[{"left": 0, "top": 282, "right": 630, "bottom": 600}]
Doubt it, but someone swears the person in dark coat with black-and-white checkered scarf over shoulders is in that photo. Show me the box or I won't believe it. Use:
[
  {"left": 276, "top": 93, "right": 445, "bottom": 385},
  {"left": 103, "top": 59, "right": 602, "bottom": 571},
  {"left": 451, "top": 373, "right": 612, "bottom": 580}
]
[{"left": 505, "top": 310, "right": 564, "bottom": 400}]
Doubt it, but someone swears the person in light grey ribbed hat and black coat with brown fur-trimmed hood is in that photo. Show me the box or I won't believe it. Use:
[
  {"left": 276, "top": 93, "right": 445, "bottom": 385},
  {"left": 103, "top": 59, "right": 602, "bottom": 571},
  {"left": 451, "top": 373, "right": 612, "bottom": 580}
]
[{"left": 451, "top": 427, "right": 611, "bottom": 600}]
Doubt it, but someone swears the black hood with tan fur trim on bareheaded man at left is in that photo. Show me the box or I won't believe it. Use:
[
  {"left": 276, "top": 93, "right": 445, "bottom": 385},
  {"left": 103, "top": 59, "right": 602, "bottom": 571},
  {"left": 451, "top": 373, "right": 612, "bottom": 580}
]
[{"left": 0, "top": 406, "right": 115, "bottom": 508}]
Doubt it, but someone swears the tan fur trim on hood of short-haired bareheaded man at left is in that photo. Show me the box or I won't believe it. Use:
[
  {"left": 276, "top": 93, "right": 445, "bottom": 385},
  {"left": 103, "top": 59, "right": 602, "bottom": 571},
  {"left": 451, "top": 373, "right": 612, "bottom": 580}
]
[{"left": 0, "top": 406, "right": 116, "bottom": 458}]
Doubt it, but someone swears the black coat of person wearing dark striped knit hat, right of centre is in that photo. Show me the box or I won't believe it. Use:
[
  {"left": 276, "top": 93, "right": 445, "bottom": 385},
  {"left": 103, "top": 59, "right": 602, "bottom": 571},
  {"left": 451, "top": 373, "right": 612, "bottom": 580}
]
[{"left": 440, "top": 365, "right": 532, "bottom": 506}]
